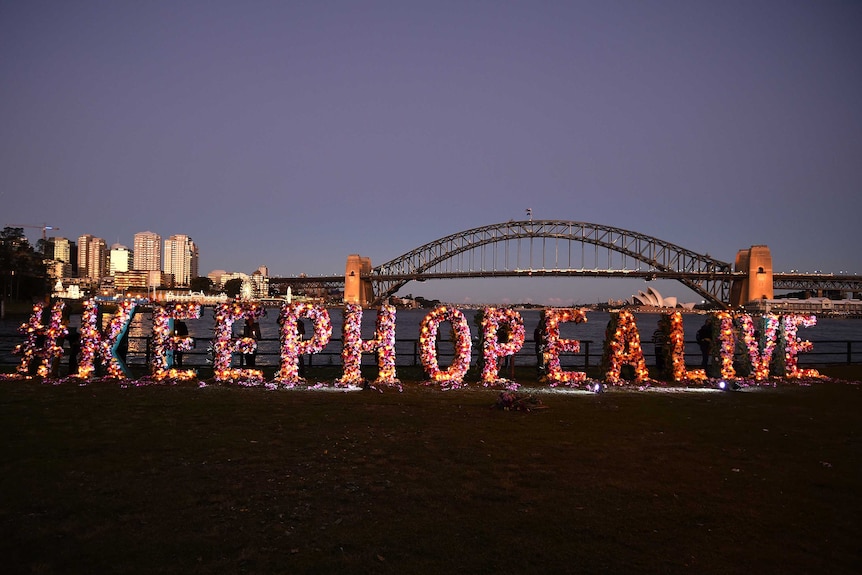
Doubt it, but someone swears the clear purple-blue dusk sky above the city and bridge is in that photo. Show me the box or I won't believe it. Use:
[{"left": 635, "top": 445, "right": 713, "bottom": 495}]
[{"left": 0, "top": 0, "right": 862, "bottom": 303}]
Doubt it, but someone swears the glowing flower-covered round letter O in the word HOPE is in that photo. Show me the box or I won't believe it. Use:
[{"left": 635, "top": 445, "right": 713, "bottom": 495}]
[{"left": 419, "top": 306, "right": 472, "bottom": 387}]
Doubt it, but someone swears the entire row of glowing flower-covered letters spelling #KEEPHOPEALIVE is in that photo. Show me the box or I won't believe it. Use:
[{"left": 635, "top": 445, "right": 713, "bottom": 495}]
[{"left": 5, "top": 299, "right": 822, "bottom": 388}]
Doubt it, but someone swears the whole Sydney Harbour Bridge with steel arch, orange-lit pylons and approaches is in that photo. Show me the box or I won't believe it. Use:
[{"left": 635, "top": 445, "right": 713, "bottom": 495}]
[{"left": 270, "top": 220, "right": 862, "bottom": 307}]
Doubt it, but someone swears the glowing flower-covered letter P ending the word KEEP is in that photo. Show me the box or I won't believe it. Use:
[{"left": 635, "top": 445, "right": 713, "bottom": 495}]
[{"left": 276, "top": 303, "right": 332, "bottom": 386}]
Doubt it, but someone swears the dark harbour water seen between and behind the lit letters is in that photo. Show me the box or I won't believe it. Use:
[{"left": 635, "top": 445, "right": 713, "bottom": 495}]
[{"left": 0, "top": 308, "right": 862, "bottom": 366}]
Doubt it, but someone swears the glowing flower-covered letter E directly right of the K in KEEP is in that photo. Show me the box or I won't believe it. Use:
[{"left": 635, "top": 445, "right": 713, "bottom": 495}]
[{"left": 150, "top": 303, "right": 201, "bottom": 381}]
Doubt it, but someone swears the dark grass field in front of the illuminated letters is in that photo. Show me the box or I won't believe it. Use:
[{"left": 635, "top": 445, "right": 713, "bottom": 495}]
[{"left": 0, "top": 366, "right": 862, "bottom": 574}]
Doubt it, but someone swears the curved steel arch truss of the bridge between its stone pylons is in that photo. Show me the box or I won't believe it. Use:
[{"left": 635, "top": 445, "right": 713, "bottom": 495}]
[{"left": 368, "top": 220, "right": 744, "bottom": 306}]
